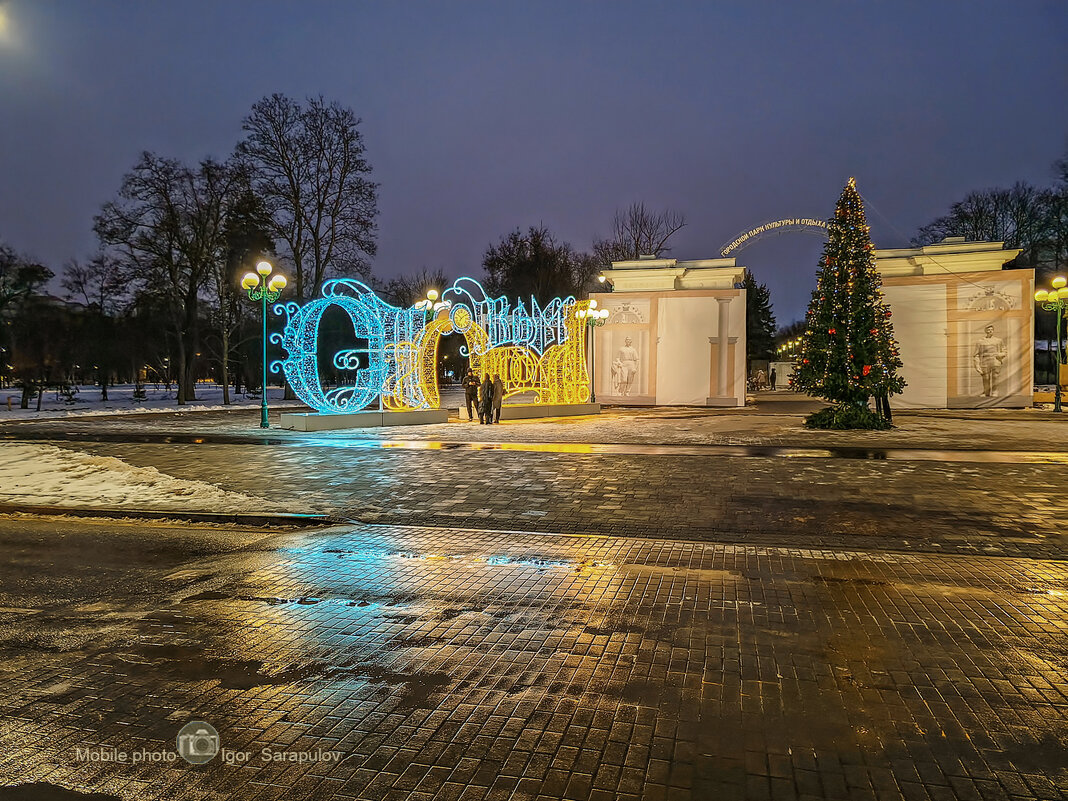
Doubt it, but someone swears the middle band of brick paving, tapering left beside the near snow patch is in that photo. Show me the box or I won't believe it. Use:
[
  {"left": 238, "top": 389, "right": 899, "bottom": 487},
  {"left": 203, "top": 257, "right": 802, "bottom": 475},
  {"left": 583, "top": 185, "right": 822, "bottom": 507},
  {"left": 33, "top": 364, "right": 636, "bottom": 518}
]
[{"left": 54, "top": 441, "right": 1068, "bottom": 559}]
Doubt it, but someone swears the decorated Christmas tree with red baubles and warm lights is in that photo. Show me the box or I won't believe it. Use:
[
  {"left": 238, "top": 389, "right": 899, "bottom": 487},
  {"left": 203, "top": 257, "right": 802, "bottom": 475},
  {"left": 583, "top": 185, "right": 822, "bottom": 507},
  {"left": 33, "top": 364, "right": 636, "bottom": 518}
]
[{"left": 792, "top": 178, "right": 905, "bottom": 428}]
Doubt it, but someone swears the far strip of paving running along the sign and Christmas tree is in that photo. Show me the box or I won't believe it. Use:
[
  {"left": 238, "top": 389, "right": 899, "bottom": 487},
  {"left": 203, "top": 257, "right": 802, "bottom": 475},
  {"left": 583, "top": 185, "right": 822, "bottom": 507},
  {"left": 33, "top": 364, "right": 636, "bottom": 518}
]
[{"left": 6, "top": 393, "right": 1068, "bottom": 453}]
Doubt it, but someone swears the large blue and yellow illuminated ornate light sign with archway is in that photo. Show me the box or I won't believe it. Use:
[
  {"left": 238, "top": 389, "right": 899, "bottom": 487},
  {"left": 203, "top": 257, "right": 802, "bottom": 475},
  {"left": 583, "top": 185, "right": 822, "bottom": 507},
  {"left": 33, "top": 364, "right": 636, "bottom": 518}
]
[{"left": 271, "top": 278, "right": 590, "bottom": 414}]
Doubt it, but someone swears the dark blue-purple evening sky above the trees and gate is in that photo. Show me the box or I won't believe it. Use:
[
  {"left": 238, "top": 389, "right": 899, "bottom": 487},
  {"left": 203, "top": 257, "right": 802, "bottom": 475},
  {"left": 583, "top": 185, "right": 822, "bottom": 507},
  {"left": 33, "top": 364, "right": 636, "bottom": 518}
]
[{"left": 0, "top": 0, "right": 1068, "bottom": 323}]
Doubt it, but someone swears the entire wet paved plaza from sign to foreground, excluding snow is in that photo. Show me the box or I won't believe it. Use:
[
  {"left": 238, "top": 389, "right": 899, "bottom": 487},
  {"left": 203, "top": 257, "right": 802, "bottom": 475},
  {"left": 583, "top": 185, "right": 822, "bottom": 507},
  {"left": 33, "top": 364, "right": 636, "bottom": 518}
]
[{"left": 0, "top": 407, "right": 1068, "bottom": 801}]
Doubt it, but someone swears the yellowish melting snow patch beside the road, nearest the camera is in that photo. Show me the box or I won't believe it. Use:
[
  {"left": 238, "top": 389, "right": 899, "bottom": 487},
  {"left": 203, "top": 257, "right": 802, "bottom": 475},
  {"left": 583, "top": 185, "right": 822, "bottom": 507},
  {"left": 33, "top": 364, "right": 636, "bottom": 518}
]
[{"left": 0, "top": 443, "right": 300, "bottom": 514}]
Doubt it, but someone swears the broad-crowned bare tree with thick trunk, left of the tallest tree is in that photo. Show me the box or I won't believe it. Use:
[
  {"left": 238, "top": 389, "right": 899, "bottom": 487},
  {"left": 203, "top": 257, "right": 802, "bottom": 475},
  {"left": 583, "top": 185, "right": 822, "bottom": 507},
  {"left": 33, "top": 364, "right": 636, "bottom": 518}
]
[{"left": 94, "top": 153, "right": 240, "bottom": 405}]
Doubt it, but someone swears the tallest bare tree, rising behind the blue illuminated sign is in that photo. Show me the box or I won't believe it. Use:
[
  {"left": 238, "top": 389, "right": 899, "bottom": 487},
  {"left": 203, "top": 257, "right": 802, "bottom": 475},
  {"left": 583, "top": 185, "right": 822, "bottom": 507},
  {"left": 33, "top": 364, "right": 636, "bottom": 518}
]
[{"left": 237, "top": 94, "right": 378, "bottom": 300}]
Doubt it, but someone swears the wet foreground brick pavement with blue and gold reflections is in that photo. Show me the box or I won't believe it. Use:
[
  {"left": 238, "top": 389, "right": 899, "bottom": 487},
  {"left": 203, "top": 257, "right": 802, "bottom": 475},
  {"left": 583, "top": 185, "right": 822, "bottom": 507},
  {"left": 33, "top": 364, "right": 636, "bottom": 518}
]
[{"left": 0, "top": 521, "right": 1068, "bottom": 801}]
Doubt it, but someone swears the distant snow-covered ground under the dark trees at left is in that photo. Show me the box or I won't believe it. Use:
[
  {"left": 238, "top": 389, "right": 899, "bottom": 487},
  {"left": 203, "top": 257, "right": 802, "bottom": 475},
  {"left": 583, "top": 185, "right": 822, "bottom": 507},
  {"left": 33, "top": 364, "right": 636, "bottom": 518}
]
[{"left": 0, "top": 383, "right": 303, "bottom": 420}]
